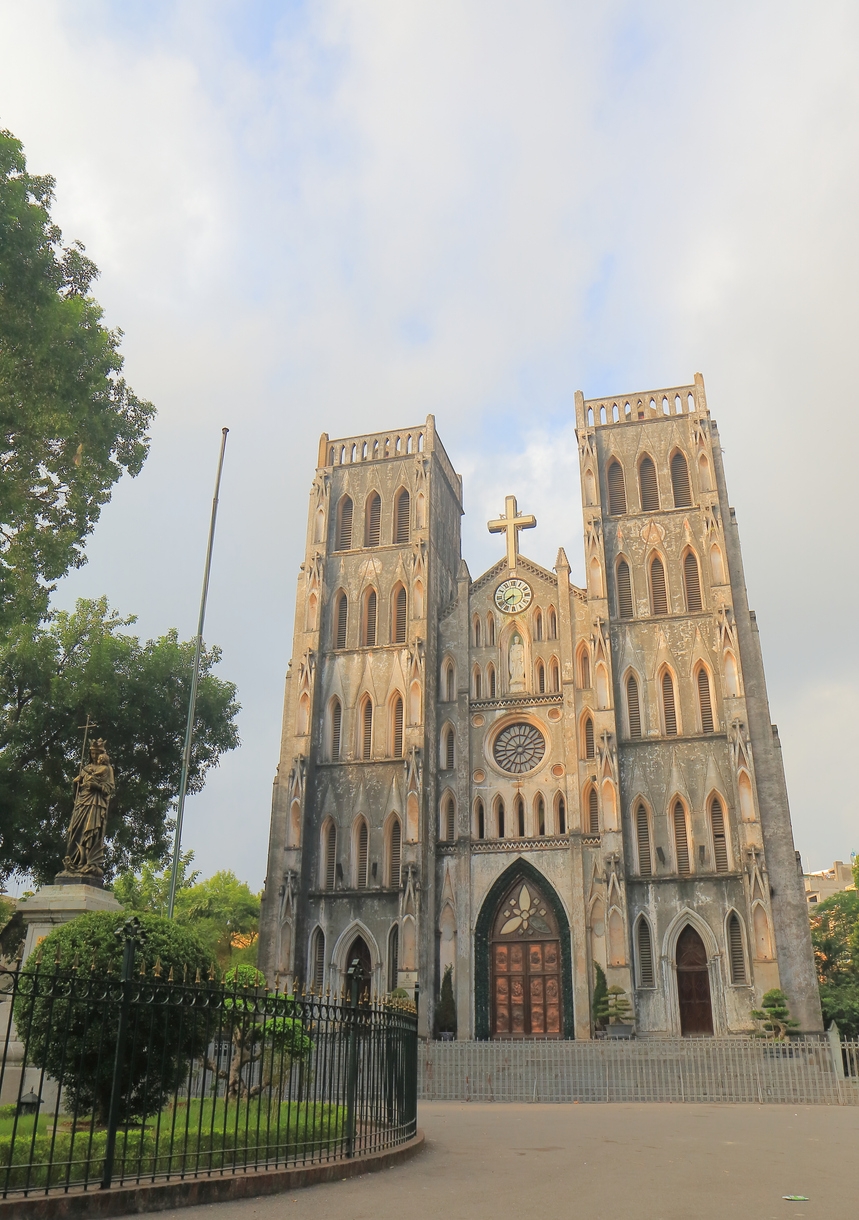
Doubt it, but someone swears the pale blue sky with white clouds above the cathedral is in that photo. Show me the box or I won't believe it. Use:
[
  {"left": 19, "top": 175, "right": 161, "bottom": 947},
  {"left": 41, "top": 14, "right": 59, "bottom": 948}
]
[{"left": 0, "top": 0, "right": 859, "bottom": 888}]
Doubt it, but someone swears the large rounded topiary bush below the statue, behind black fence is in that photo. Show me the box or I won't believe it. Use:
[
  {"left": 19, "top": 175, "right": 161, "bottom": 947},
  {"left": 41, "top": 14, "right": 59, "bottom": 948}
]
[{"left": 15, "top": 911, "right": 217, "bottom": 1122}]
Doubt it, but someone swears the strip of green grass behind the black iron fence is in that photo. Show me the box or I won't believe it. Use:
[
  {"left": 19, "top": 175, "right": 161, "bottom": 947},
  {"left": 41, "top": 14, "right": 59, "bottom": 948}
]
[{"left": 0, "top": 1099, "right": 345, "bottom": 1190}]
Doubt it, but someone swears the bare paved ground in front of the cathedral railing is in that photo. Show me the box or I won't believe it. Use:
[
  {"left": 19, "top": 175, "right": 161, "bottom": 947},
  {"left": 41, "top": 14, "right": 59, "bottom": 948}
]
[{"left": 142, "top": 1102, "right": 859, "bottom": 1220}]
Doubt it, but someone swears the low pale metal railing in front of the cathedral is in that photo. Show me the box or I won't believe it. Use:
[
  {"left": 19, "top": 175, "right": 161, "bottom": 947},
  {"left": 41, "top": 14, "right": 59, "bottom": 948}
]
[{"left": 419, "top": 1038, "right": 859, "bottom": 1105}]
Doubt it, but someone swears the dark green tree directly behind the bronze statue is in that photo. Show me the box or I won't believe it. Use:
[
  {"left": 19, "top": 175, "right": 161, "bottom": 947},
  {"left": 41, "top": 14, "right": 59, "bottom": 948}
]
[{"left": 0, "top": 598, "right": 239, "bottom": 882}]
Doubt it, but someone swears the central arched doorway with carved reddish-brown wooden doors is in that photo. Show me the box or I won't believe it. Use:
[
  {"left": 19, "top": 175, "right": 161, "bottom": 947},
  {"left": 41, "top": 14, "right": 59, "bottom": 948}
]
[{"left": 489, "top": 877, "right": 564, "bottom": 1038}]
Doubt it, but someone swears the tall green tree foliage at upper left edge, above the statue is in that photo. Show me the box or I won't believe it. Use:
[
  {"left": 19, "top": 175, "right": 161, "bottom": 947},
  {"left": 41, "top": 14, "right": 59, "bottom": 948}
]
[{"left": 0, "top": 131, "right": 155, "bottom": 631}]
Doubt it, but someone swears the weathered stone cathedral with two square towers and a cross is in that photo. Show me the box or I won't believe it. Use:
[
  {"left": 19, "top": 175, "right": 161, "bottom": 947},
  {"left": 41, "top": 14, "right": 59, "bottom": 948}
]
[{"left": 260, "top": 375, "right": 822, "bottom": 1038}]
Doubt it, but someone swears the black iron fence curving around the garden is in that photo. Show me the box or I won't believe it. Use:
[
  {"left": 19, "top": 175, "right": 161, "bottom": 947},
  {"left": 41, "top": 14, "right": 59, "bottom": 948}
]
[{"left": 0, "top": 946, "right": 417, "bottom": 1198}]
